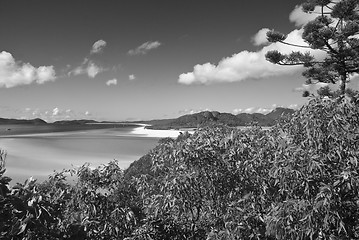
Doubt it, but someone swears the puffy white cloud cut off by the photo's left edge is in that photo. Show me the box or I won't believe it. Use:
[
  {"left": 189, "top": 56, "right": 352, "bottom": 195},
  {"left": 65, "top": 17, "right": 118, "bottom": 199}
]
[{"left": 0, "top": 51, "right": 56, "bottom": 88}]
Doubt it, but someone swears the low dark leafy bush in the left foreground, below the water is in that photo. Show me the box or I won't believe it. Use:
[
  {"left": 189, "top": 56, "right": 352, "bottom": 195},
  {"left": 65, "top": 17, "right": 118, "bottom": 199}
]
[{"left": 0, "top": 159, "right": 143, "bottom": 239}]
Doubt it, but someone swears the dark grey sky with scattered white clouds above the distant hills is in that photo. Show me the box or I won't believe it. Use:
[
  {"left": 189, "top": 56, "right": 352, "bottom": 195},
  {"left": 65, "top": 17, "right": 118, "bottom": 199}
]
[{"left": 0, "top": 0, "right": 358, "bottom": 122}]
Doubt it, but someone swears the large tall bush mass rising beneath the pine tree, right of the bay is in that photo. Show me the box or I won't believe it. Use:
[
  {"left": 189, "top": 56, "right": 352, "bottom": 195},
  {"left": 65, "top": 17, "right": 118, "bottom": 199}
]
[{"left": 134, "top": 98, "right": 359, "bottom": 239}]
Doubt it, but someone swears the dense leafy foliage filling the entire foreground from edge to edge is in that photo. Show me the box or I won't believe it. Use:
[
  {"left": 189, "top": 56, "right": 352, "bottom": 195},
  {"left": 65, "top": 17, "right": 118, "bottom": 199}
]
[{"left": 0, "top": 97, "right": 359, "bottom": 240}]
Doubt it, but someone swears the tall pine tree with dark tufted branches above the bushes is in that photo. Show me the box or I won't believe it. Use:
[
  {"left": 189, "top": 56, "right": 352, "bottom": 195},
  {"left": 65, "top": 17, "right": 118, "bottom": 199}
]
[{"left": 266, "top": 0, "right": 359, "bottom": 94}]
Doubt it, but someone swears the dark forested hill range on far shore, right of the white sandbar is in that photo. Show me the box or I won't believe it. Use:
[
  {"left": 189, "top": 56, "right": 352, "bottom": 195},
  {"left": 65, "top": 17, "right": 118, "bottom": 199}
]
[{"left": 145, "top": 107, "right": 294, "bottom": 129}]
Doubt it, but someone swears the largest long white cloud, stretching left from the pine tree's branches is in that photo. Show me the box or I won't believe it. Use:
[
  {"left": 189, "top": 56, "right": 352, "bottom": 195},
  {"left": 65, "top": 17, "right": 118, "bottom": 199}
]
[{"left": 178, "top": 30, "right": 312, "bottom": 85}]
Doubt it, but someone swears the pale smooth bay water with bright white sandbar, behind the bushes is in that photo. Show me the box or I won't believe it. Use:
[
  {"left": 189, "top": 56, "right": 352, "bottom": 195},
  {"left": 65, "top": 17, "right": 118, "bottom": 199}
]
[{"left": 0, "top": 126, "right": 183, "bottom": 183}]
